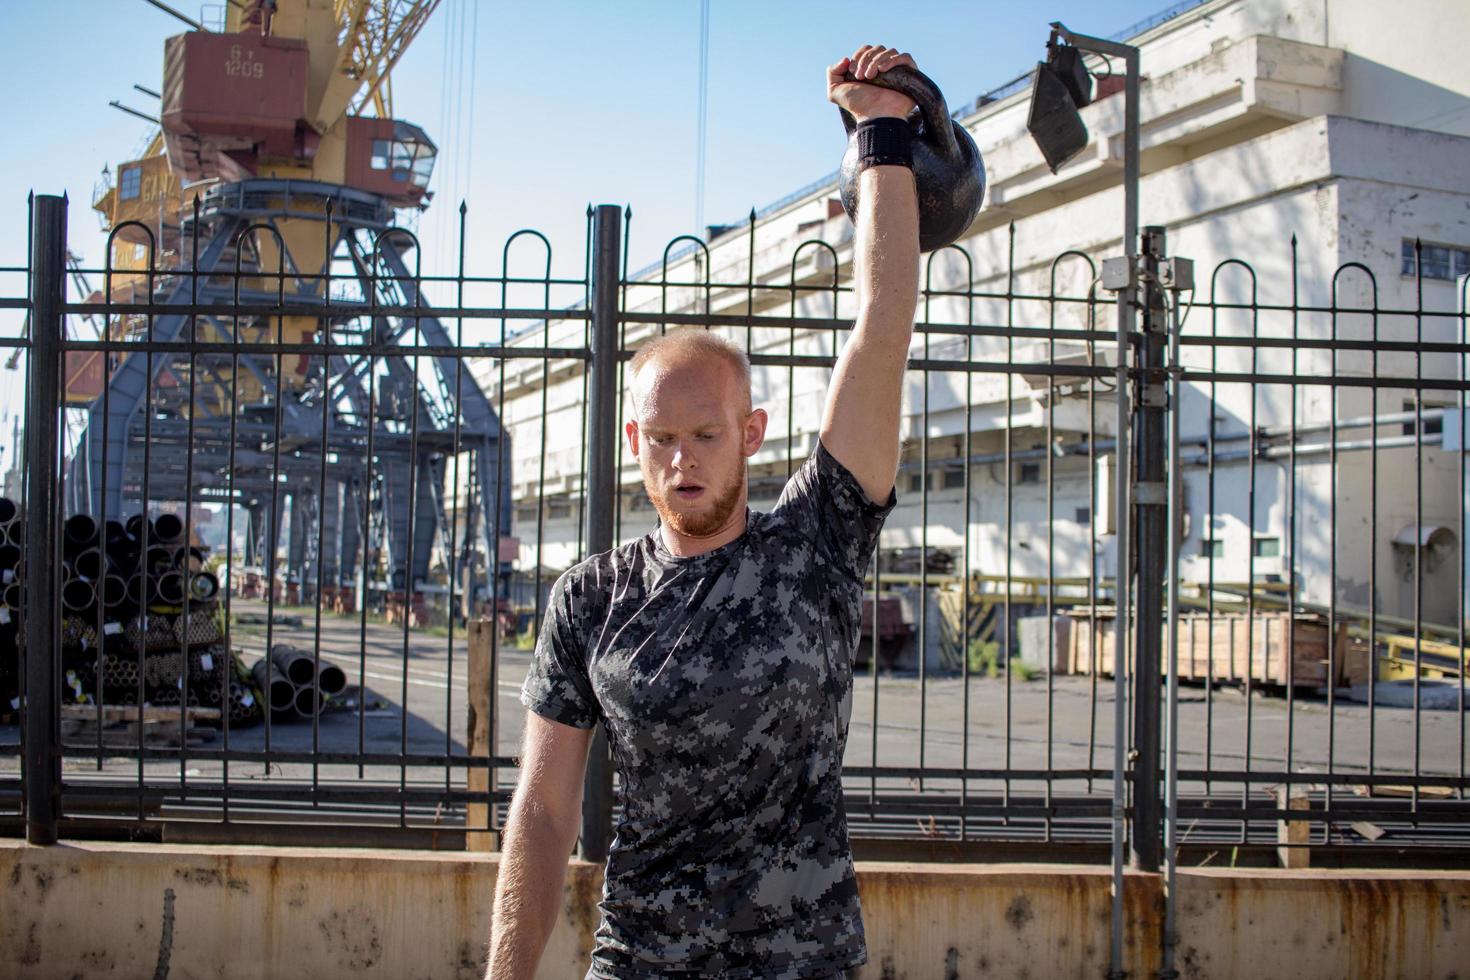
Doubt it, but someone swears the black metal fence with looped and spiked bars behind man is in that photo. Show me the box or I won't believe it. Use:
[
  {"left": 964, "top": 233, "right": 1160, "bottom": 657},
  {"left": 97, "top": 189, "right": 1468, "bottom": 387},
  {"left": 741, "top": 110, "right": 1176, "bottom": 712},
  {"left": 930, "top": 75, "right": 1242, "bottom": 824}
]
[{"left": 0, "top": 189, "right": 1470, "bottom": 867}]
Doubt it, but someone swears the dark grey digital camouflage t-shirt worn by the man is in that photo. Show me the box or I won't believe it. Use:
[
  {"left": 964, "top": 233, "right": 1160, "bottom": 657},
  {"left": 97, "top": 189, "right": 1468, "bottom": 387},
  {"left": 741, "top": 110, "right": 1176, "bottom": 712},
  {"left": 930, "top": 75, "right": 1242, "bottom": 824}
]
[{"left": 520, "top": 445, "right": 894, "bottom": 980}]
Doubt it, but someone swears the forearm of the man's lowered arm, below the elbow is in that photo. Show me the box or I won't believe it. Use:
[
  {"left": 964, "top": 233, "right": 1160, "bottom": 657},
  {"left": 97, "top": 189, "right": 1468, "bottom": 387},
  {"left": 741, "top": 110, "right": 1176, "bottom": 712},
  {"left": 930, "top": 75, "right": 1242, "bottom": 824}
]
[{"left": 485, "top": 808, "right": 572, "bottom": 980}]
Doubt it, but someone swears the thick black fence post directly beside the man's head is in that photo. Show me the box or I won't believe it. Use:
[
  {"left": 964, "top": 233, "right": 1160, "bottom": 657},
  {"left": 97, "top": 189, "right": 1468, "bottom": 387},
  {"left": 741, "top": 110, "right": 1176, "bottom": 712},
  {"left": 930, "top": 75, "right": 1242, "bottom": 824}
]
[{"left": 578, "top": 204, "right": 623, "bottom": 861}]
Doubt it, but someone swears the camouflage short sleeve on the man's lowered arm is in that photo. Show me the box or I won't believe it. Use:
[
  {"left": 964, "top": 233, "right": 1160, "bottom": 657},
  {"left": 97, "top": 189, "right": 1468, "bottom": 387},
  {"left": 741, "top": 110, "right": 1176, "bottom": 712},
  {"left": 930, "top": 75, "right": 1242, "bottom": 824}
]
[{"left": 520, "top": 569, "right": 600, "bottom": 729}]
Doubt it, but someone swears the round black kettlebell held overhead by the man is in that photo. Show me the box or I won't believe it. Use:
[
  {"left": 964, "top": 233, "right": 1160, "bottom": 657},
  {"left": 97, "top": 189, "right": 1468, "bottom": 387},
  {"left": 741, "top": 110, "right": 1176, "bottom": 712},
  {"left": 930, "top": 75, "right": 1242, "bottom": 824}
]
[{"left": 838, "top": 65, "right": 985, "bottom": 251}]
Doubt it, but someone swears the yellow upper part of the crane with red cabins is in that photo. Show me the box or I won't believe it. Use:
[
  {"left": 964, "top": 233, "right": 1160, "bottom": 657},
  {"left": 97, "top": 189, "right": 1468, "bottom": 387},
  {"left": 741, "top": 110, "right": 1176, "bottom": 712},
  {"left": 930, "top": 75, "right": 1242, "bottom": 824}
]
[{"left": 84, "top": 0, "right": 440, "bottom": 404}]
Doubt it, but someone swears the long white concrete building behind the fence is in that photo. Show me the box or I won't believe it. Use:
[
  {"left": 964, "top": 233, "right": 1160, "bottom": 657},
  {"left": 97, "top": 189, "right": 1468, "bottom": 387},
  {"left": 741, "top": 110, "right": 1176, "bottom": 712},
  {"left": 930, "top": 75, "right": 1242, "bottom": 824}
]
[{"left": 481, "top": 0, "right": 1470, "bottom": 623}]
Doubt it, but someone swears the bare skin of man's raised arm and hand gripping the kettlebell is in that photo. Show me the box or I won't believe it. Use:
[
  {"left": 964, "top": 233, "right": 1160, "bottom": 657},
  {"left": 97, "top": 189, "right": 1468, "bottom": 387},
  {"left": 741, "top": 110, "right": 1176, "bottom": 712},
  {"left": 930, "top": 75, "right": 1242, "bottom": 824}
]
[{"left": 822, "top": 46, "right": 919, "bottom": 504}]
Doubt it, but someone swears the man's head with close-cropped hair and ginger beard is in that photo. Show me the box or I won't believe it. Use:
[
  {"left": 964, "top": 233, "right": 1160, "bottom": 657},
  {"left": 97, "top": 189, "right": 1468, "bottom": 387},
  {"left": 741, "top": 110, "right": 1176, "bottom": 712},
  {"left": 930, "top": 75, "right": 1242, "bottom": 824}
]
[{"left": 625, "top": 354, "right": 766, "bottom": 538}]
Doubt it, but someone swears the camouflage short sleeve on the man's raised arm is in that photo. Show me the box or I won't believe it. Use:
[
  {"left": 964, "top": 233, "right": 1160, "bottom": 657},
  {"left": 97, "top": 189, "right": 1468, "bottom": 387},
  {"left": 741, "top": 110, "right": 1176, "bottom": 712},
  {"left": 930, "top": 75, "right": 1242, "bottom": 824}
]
[{"left": 776, "top": 442, "right": 898, "bottom": 579}]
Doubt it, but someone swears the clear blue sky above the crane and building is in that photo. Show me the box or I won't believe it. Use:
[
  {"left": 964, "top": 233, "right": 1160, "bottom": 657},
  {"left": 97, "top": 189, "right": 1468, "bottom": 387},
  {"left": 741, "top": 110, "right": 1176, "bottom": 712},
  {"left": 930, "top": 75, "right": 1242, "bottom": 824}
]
[{"left": 0, "top": 0, "right": 1169, "bottom": 282}]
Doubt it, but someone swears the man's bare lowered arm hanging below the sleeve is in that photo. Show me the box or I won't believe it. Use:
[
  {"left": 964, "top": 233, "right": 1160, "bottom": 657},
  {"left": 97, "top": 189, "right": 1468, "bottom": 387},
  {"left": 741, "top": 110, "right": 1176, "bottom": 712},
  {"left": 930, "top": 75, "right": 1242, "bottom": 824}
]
[{"left": 485, "top": 711, "right": 592, "bottom": 980}]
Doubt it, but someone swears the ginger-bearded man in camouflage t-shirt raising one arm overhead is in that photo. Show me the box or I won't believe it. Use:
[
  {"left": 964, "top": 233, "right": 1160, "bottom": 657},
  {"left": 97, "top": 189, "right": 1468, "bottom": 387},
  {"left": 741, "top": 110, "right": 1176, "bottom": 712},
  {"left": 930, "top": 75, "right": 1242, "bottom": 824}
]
[{"left": 490, "top": 46, "right": 919, "bottom": 980}]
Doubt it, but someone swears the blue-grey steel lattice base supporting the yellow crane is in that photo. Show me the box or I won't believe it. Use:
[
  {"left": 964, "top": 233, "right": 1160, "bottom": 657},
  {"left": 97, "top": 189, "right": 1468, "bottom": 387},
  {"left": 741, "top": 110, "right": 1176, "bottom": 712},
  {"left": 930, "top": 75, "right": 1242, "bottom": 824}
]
[{"left": 65, "top": 179, "right": 510, "bottom": 605}]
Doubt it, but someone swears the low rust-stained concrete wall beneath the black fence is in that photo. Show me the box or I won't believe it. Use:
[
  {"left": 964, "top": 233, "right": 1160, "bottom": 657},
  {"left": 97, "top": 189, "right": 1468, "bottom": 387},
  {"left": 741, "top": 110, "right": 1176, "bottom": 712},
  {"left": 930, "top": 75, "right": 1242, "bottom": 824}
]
[{"left": 0, "top": 842, "right": 1470, "bottom": 980}]
